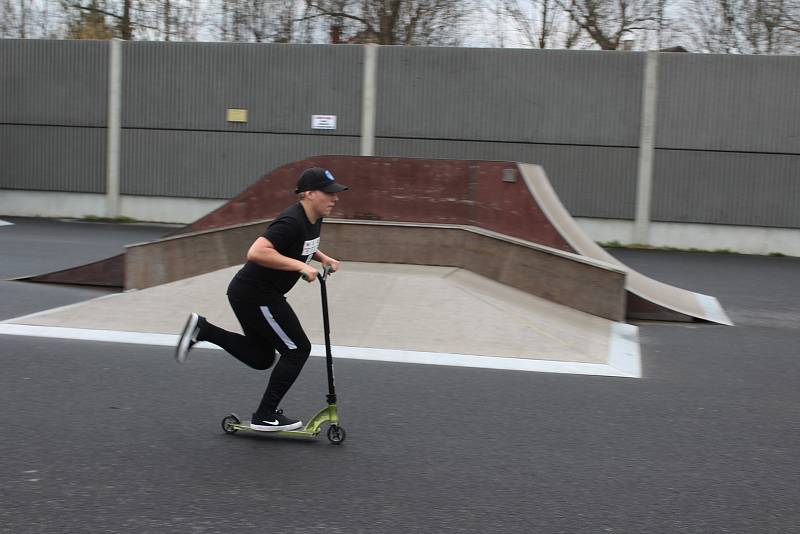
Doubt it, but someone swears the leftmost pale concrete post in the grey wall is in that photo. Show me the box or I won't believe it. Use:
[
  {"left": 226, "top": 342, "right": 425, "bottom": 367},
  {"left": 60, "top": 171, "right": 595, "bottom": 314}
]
[{"left": 106, "top": 39, "right": 122, "bottom": 217}]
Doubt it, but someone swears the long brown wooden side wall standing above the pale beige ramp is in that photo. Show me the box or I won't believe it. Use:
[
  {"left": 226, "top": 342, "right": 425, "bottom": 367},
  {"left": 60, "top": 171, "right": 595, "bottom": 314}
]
[{"left": 125, "top": 219, "right": 625, "bottom": 321}]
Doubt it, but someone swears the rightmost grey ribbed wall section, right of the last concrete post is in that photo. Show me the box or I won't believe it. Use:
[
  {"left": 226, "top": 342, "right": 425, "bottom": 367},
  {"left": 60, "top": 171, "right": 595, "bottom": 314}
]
[{"left": 652, "top": 54, "right": 800, "bottom": 228}]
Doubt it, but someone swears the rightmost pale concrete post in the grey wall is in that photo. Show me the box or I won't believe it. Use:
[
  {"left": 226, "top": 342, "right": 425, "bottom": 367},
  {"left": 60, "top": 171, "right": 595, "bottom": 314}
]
[{"left": 633, "top": 52, "right": 658, "bottom": 245}]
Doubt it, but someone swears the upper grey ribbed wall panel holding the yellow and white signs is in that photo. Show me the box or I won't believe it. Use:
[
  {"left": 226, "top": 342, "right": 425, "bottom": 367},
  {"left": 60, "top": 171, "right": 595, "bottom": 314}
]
[{"left": 122, "top": 42, "right": 364, "bottom": 136}]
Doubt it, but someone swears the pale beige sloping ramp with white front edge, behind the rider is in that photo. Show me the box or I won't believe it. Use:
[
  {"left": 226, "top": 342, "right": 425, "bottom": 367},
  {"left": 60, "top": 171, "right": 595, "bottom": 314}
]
[{"left": 0, "top": 262, "right": 641, "bottom": 377}]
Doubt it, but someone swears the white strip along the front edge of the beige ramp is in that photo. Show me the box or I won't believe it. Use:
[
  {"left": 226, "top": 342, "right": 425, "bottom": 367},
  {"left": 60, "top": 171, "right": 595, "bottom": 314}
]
[{"left": 0, "top": 323, "right": 641, "bottom": 378}]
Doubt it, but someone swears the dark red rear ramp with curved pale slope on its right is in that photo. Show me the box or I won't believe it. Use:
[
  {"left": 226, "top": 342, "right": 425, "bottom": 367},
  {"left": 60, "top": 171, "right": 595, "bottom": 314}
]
[{"left": 17, "top": 156, "right": 731, "bottom": 324}]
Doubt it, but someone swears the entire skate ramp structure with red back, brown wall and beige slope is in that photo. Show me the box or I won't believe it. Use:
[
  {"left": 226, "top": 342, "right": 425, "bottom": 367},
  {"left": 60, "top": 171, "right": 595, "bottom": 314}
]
[{"left": 3, "top": 156, "right": 744, "bottom": 386}]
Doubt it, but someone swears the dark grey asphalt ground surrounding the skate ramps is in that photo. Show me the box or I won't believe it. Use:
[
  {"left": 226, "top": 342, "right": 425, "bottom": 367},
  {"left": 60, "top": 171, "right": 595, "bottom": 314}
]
[{"left": 0, "top": 219, "right": 800, "bottom": 533}]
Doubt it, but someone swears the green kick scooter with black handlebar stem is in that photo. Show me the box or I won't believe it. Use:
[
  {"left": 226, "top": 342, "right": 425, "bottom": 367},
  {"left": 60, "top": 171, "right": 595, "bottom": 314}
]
[{"left": 222, "top": 265, "right": 345, "bottom": 445}]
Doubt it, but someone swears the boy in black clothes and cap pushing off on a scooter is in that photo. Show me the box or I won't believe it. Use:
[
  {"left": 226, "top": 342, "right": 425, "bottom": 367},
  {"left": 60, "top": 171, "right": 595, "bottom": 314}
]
[{"left": 175, "top": 167, "right": 347, "bottom": 432}]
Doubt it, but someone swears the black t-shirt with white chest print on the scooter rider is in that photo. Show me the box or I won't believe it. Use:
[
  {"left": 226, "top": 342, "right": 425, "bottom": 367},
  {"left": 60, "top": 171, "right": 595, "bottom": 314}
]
[{"left": 228, "top": 202, "right": 322, "bottom": 300}]
